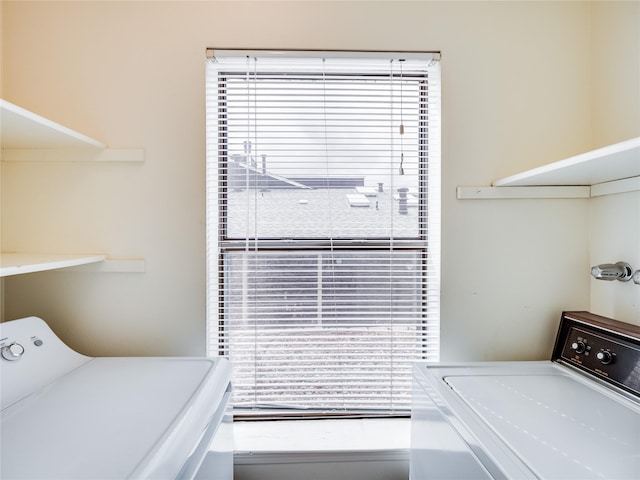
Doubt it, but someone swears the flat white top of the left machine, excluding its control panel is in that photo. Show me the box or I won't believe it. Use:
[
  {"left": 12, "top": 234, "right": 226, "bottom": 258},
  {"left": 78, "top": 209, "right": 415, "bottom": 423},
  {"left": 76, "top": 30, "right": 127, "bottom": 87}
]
[{"left": 0, "top": 358, "right": 229, "bottom": 479}]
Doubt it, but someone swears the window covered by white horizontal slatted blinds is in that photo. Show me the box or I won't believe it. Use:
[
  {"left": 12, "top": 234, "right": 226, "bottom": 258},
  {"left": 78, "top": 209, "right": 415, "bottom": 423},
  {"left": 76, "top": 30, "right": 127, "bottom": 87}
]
[{"left": 206, "top": 50, "right": 440, "bottom": 414}]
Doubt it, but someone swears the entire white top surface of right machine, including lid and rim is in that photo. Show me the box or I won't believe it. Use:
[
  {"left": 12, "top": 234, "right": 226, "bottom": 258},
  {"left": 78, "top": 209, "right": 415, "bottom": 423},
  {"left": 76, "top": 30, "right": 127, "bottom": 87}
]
[{"left": 424, "top": 362, "right": 640, "bottom": 480}]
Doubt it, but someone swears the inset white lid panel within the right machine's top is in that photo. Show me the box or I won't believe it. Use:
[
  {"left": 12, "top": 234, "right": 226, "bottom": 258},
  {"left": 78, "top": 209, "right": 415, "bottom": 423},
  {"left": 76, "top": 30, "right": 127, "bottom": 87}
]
[{"left": 445, "top": 374, "right": 640, "bottom": 480}]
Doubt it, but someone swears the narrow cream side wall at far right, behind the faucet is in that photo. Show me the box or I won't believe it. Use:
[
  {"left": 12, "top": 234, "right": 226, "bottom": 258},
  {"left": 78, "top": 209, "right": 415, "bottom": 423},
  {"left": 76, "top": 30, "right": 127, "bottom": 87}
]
[{"left": 589, "top": 1, "right": 640, "bottom": 325}]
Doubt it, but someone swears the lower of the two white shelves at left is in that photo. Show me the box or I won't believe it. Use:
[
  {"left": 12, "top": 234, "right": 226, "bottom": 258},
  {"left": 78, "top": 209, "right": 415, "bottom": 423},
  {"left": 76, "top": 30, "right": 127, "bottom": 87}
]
[{"left": 0, "top": 253, "right": 106, "bottom": 277}]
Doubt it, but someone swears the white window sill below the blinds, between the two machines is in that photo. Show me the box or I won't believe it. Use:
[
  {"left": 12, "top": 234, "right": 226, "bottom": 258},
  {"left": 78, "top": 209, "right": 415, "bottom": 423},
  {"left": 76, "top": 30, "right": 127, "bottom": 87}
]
[{"left": 233, "top": 418, "right": 411, "bottom": 455}]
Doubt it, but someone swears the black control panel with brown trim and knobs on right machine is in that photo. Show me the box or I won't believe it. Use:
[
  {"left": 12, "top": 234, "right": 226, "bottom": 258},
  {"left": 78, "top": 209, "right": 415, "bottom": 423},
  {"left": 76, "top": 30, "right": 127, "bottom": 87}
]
[{"left": 552, "top": 312, "right": 640, "bottom": 396}]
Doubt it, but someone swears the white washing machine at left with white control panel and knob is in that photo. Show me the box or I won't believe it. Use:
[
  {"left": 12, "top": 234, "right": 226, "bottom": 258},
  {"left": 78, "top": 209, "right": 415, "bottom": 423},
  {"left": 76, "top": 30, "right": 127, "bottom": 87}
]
[{"left": 0, "top": 317, "right": 233, "bottom": 480}]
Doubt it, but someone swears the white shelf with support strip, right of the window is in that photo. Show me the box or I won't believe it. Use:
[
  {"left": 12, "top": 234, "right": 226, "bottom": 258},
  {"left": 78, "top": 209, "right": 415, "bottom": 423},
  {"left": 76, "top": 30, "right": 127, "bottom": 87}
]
[{"left": 457, "top": 137, "right": 640, "bottom": 199}]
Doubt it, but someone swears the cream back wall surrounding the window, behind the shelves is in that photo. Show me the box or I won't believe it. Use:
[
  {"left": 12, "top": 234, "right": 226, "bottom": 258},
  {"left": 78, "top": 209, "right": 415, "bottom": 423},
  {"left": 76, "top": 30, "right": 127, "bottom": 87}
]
[{"left": 1, "top": 1, "right": 640, "bottom": 360}]
